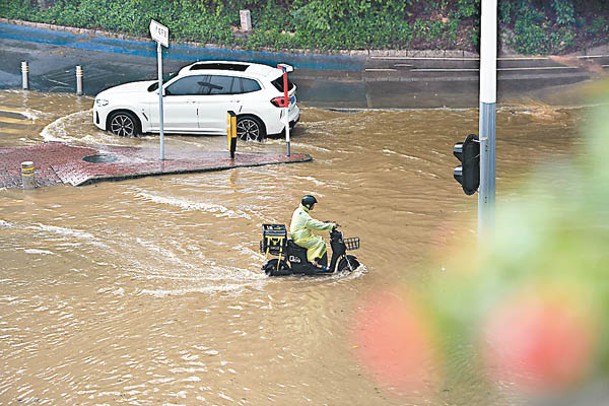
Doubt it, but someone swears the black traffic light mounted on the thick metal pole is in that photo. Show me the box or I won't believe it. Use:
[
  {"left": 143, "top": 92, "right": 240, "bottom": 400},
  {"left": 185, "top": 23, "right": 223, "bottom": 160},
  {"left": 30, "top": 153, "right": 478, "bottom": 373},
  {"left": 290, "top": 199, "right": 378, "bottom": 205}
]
[{"left": 453, "top": 134, "right": 480, "bottom": 196}]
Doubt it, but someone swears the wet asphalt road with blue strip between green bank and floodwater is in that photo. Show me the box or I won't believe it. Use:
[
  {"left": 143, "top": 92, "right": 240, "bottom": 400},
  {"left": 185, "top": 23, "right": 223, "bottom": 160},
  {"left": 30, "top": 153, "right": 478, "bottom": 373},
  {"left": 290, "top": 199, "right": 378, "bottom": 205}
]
[{"left": 0, "top": 21, "right": 609, "bottom": 109}]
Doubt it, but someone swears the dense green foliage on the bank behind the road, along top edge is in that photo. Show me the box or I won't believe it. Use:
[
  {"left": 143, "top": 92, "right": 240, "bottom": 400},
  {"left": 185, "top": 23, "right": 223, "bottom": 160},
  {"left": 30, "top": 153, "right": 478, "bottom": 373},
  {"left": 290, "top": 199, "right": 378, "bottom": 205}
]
[{"left": 0, "top": 0, "right": 609, "bottom": 54}]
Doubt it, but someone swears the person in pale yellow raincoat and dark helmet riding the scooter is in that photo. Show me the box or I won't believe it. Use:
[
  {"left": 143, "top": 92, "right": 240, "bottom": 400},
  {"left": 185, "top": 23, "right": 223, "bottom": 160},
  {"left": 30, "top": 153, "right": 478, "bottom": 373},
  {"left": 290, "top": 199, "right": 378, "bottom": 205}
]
[{"left": 290, "top": 195, "right": 336, "bottom": 270}]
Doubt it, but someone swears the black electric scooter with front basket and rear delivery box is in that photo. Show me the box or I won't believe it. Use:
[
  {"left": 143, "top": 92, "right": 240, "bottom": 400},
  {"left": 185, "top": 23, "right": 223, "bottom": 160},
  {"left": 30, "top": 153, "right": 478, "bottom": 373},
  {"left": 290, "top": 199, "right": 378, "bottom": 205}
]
[{"left": 260, "top": 224, "right": 360, "bottom": 276}]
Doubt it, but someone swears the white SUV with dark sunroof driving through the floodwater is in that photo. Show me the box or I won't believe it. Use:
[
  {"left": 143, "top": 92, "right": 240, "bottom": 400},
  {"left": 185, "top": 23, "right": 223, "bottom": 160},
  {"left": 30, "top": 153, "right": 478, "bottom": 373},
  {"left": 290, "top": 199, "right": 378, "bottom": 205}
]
[{"left": 93, "top": 61, "right": 300, "bottom": 141}]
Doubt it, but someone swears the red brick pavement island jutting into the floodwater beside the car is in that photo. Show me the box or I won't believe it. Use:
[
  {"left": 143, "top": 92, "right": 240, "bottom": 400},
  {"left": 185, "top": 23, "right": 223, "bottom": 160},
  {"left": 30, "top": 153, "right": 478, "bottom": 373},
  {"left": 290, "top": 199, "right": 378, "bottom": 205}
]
[{"left": 0, "top": 142, "right": 312, "bottom": 189}]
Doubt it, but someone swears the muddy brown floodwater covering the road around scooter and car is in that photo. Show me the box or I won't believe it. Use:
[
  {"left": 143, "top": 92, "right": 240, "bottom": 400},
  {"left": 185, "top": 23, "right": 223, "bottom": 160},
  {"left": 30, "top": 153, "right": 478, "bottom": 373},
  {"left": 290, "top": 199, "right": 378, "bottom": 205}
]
[{"left": 0, "top": 91, "right": 583, "bottom": 405}]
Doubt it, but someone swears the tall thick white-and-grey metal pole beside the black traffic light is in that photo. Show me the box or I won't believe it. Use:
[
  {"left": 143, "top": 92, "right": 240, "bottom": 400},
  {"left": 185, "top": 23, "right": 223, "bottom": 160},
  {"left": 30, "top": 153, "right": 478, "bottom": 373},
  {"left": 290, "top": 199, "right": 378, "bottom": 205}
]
[{"left": 478, "top": 0, "right": 497, "bottom": 241}]
